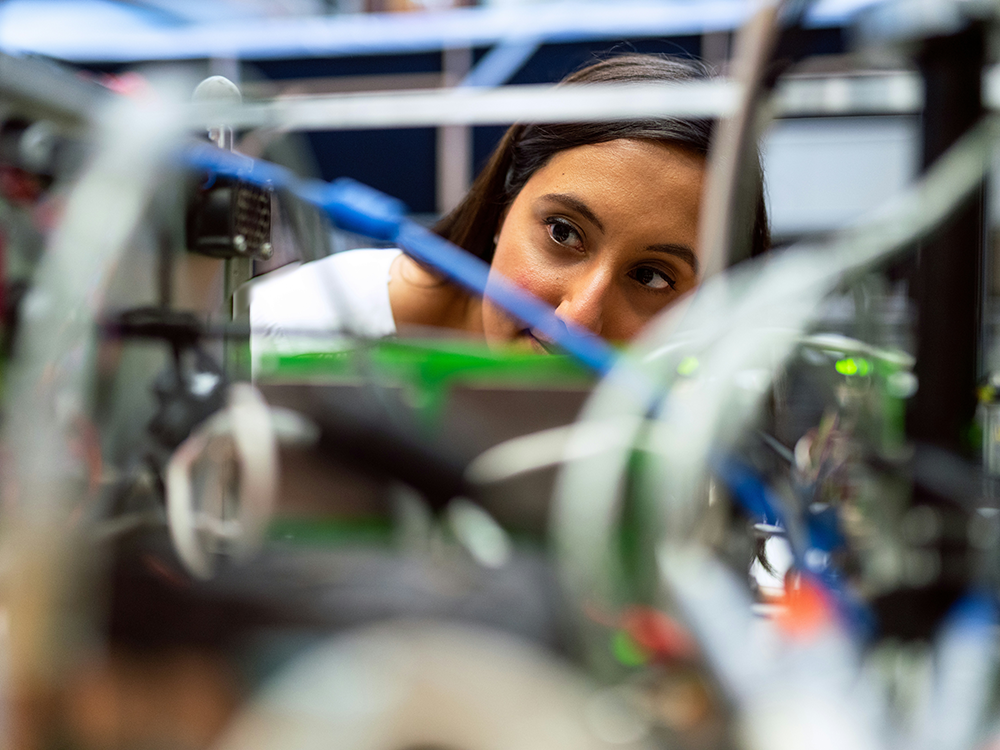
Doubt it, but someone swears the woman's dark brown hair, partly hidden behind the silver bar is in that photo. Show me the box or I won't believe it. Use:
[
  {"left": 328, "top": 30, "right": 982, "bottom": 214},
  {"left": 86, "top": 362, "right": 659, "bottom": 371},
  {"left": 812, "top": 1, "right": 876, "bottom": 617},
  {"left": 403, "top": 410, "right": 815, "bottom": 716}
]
[{"left": 434, "top": 54, "right": 770, "bottom": 261}]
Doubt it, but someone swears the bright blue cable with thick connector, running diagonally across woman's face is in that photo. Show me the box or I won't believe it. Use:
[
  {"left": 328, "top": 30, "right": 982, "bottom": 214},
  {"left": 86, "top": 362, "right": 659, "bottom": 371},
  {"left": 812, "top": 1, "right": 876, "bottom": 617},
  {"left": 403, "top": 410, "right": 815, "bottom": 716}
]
[{"left": 184, "top": 145, "right": 618, "bottom": 375}]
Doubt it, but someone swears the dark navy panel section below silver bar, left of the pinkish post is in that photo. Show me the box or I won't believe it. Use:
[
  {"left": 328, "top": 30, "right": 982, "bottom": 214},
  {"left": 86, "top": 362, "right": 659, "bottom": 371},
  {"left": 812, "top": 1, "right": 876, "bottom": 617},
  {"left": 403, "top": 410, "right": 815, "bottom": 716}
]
[{"left": 308, "top": 128, "right": 436, "bottom": 213}]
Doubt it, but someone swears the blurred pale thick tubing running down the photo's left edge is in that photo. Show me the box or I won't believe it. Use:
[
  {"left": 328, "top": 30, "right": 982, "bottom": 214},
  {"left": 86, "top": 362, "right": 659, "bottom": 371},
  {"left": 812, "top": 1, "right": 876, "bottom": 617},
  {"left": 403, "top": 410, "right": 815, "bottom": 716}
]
[{"left": 0, "top": 82, "right": 191, "bottom": 747}]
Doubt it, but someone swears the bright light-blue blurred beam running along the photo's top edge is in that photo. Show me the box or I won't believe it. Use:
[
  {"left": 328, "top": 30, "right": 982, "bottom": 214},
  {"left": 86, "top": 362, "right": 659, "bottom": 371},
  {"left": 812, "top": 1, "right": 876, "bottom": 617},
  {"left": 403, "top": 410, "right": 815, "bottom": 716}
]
[{"left": 0, "top": 0, "right": 876, "bottom": 63}]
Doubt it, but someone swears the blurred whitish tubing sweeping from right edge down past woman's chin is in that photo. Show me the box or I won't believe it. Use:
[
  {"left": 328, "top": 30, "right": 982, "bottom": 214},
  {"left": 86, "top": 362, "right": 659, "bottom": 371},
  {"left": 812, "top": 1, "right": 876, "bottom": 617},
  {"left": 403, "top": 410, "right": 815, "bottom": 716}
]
[{"left": 552, "top": 110, "right": 997, "bottom": 658}]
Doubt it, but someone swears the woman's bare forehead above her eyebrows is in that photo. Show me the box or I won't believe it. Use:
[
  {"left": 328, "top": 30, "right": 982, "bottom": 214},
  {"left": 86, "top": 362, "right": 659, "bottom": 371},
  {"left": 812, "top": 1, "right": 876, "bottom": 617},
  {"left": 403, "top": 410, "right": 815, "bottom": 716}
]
[{"left": 518, "top": 139, "right": 705, "bottom": 235}]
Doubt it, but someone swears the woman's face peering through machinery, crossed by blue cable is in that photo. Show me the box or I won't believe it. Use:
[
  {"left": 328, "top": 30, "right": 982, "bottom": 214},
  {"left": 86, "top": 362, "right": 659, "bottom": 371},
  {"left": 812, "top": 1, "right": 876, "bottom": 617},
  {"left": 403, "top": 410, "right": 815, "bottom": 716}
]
[{"left": 483, "top": 139, "right": 705, "bottom": 351}]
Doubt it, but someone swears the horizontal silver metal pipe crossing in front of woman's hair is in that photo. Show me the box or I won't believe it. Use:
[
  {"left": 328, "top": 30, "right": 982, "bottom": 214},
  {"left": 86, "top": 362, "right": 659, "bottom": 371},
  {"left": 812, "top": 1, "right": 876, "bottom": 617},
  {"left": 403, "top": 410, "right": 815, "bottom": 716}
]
[{"left": 188, "top": 73, "right": 932, "bottom": 131}]
